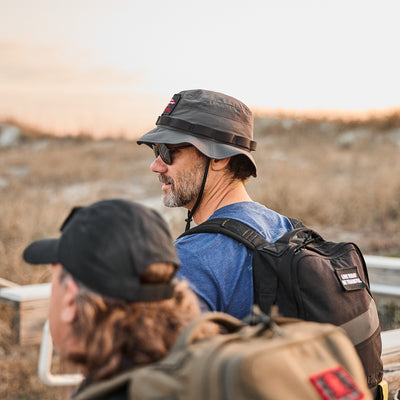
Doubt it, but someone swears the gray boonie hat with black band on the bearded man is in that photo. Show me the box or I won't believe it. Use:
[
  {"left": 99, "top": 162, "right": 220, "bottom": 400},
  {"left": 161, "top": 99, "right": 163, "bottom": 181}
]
[{"left": 137, "top": 89, "right": 257, "bottom": 176}]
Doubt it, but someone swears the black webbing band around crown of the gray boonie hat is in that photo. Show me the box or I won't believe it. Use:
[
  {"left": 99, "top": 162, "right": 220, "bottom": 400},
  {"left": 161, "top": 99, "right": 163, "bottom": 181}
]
[{"left": 156, "top": 115, "right": 257, "bottom": 151}]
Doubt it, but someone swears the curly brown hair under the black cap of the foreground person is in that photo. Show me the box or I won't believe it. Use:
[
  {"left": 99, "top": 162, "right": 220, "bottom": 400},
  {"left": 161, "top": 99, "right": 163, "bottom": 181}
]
[{"left": 61, "top": 264, "right": 200, "bottom": 381}]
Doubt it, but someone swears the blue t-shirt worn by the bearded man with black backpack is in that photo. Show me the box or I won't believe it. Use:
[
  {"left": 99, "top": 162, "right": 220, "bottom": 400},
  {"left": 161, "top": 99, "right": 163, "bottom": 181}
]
[{"left": 175, "top": 201, "right": 293, "bottom": 319}]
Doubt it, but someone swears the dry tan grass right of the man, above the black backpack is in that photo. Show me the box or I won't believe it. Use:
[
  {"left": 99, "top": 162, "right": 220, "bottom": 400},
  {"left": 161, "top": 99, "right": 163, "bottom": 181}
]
[{"left": 249, "top": 116, "right": 400, "bottom": 255}]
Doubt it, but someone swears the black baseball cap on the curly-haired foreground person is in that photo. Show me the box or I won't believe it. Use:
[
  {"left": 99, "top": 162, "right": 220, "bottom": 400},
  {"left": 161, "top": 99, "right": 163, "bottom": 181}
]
[{"left": 23, "top": 199, "right": 179, "bottom": 302}]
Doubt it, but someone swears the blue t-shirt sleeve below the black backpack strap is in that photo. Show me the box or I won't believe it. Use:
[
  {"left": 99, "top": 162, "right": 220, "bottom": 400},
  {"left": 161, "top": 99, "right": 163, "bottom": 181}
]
[{"left": 175, "top": 233, "right": 253, "bottom": 318}]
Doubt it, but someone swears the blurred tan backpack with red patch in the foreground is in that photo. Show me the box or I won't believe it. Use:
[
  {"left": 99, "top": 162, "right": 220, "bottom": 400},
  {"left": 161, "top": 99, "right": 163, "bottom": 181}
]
[{"left": 74, "top": 312, "right": 372, "bottom": 400}]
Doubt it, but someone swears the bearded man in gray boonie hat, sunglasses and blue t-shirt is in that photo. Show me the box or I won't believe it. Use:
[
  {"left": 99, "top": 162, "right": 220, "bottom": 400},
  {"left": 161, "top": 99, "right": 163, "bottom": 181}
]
[{"left": 138, "top": 89, "right": 293, "bottom": 318}]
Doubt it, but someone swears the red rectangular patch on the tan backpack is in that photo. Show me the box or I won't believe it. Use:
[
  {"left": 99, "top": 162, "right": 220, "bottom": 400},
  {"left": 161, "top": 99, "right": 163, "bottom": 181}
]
[{"left": 310, "top": 366, "right": 364, "bottom": 400}]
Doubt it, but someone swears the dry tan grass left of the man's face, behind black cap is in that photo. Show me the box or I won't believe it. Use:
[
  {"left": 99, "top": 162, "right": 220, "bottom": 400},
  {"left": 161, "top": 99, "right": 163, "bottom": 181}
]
[{"left": 0, "top": 138, "right": 159, "bottom": 284}]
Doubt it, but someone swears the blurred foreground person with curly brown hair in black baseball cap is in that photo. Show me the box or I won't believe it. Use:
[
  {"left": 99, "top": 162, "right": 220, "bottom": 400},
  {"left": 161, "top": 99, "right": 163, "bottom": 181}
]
[{"left": 23, "top": 199, "right": 200, "bottom": 399}]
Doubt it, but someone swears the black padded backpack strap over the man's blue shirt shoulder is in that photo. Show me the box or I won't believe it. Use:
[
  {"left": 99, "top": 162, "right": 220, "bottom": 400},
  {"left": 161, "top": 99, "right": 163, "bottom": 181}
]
[{"left": 179, "top": 218, "right": 268, "bottom": 249}]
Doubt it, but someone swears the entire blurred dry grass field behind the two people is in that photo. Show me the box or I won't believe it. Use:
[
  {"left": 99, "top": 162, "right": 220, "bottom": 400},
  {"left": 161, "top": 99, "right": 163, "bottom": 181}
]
[{"left": 0, "top": 114, "right": 400, "bottom": 400}]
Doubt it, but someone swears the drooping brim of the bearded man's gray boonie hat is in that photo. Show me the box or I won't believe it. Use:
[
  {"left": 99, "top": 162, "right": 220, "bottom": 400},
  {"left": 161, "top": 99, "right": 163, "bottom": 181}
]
[{"left": 137, "top": 126, "right": 257, "bottom": 170}]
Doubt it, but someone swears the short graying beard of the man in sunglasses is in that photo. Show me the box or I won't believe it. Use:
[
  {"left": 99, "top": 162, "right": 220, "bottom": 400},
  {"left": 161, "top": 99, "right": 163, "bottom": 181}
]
[{"left": 161, "top": 160, "right": 204, "bottom": 207}]
